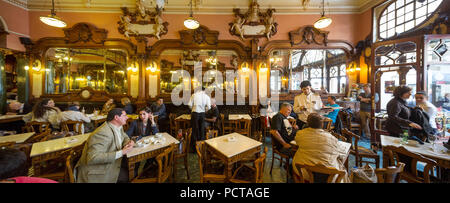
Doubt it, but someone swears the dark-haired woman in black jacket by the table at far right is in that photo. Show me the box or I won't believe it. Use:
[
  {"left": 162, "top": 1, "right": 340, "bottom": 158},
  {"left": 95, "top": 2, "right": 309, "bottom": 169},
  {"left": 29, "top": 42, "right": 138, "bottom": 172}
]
[{"left": 386, "top": 86, "right": 422, "bottom": 137}]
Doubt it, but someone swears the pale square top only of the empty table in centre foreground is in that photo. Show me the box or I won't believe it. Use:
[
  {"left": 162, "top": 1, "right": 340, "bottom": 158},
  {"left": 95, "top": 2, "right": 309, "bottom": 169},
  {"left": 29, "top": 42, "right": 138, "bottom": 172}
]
[{"left": 205, "top": 133, "right": 262, "bottom": 158}]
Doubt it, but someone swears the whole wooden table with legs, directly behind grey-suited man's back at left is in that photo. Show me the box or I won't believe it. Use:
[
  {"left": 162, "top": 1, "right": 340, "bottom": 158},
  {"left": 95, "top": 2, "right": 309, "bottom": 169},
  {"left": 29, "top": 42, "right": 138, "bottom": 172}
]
[{"left": 30, "top": 133, "right": 90, "bottom": 175}]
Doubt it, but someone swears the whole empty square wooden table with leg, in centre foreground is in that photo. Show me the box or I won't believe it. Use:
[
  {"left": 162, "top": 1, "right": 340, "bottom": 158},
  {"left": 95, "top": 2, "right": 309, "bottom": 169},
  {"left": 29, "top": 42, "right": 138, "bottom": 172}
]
[{"left": 205, "top": 133, "right": 262, "bottom": 181}]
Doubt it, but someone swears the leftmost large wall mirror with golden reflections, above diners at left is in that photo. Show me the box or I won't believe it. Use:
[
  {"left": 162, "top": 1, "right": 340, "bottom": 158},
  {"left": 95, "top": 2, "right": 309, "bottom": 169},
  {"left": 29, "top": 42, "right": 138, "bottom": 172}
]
[{"left": 45, "top": 48, "right": 128, "bottom": 94}]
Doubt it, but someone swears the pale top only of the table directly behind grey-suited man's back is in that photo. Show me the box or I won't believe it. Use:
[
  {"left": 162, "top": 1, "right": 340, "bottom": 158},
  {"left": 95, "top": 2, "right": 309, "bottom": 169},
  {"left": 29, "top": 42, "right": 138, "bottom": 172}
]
[{"left": 30, "top": 133, "right": 91, "bottom": 157}]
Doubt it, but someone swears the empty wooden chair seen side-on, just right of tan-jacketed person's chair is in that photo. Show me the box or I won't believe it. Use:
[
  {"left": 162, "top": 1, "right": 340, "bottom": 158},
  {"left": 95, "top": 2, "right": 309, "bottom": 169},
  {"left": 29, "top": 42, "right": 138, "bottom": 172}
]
[{"left": 342, "top": 128, "right": 380, "bottom": 168}]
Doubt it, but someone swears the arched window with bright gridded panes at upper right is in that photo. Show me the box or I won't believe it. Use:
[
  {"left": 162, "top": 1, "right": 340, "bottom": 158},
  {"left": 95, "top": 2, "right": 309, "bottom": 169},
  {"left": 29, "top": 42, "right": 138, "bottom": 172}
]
[{"left": 378, "top": 0, "right": 443, "bottom": 39}]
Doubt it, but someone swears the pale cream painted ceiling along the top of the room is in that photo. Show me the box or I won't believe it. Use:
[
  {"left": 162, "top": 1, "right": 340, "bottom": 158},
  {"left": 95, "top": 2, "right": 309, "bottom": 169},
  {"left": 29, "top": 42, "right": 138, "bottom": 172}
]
[{"left": 18, "top": 0, "right": 385, "bottom": 15}]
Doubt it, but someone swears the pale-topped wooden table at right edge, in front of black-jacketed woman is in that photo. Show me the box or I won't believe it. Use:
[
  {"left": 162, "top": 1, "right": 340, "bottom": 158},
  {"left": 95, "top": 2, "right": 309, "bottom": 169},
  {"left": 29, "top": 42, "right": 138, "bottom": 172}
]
[{"left": 380, "top": 135, "right": 450, "bottom": 168}]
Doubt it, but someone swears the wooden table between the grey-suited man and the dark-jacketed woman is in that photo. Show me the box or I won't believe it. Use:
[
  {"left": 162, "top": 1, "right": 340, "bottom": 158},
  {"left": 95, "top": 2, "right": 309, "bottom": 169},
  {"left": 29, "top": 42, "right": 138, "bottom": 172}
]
[{"left": 127, "top": 132, "right": 180, "bottom": 181}]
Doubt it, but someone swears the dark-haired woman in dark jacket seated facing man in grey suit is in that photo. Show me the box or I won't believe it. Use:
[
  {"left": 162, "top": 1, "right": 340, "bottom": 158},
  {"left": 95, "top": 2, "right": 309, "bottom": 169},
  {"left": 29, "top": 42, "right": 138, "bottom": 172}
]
[{"left": 127, "top": 107, "right": 158, "bottom": 141}]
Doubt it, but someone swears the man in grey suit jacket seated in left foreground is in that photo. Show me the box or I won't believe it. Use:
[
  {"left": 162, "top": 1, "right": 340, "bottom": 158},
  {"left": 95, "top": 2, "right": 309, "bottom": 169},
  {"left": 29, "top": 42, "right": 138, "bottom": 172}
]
[{"left": 75, "top": 108, "right": 134, "bottom": 183}]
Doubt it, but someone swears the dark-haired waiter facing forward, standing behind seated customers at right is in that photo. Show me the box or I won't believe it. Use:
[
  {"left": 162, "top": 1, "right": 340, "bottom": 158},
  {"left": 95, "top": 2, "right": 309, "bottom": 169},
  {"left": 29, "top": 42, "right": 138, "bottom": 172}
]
[{"left": 294, "top": 80, "right": 323, "bottom": 129}]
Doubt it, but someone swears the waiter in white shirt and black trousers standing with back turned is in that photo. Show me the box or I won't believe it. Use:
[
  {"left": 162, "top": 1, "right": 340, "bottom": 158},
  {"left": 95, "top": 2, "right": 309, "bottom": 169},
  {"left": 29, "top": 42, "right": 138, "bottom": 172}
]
[{"left": 188, "top": 87, "right": 211, "bottom": 144}]
